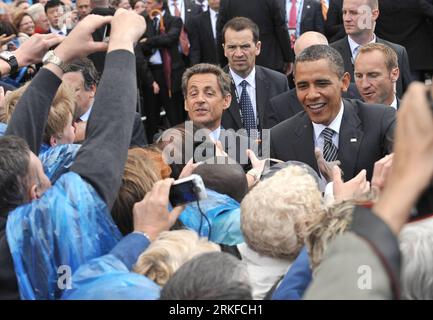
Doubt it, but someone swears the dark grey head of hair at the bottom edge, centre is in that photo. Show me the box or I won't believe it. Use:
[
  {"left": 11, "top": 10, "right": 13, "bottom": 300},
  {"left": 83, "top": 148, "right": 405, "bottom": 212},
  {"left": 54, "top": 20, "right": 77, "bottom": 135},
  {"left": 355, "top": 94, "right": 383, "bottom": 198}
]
[{"left": 160, "top": 252, "right": 253, "bottom": 300}]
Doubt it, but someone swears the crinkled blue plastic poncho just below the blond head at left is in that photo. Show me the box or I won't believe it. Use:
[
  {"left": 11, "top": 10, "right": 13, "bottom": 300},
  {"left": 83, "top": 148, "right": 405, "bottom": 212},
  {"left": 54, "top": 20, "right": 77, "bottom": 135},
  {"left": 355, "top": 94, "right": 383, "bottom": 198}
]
[{"left": 39, "top": 144, "right": 81, "bottom": 184}]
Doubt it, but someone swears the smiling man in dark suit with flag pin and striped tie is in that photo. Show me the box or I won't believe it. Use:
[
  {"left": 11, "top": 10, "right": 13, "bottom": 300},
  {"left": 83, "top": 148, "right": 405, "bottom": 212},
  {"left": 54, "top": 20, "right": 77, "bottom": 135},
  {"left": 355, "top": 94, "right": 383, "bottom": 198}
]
[{"left": 271, "top": 45, "right": 395, "bottom": 180}]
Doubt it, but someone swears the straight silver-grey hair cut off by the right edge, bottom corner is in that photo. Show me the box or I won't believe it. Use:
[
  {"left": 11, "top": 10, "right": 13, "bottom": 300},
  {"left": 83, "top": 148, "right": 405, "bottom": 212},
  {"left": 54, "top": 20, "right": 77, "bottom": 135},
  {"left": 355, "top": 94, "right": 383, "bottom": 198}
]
[{"left": 400, "top": 219, "right": 433, "bottom": 300}]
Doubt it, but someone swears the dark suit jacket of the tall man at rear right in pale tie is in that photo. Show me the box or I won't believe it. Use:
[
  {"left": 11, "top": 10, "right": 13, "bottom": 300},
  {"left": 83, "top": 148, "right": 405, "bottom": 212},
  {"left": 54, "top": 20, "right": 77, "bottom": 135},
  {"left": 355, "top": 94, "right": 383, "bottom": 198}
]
[{"left": 331, "top": 36, "right": 412, "bottom": 98}]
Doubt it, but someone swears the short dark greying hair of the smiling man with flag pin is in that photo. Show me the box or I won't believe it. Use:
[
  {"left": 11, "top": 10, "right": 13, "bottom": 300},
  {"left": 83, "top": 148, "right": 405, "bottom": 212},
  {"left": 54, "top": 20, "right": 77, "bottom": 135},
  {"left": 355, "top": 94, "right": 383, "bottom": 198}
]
[{"left": 294, "top": 44, "right": 344, "bottom": 78}]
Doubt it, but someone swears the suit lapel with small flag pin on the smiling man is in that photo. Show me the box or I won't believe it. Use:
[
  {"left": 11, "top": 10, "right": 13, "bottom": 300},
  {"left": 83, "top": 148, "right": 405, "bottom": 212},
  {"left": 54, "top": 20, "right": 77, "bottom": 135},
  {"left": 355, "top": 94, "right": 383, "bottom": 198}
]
[{"left": 338, "top": 100, "right": 364, "bottom": 177}]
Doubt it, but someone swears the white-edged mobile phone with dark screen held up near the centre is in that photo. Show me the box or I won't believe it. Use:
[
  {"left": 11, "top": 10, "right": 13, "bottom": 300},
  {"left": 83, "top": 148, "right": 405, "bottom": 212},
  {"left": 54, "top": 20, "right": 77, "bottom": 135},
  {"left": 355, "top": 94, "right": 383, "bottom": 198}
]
[{"left": 169, "top": 174, "right": 207, "bottom": 207}]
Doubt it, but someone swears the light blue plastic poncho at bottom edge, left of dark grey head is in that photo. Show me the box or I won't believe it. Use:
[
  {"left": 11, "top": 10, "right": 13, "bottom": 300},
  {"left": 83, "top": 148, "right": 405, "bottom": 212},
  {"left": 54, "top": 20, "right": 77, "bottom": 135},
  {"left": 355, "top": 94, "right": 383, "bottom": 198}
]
[{"left": 62, "top": 254, "right": 161, "bottom": 300}]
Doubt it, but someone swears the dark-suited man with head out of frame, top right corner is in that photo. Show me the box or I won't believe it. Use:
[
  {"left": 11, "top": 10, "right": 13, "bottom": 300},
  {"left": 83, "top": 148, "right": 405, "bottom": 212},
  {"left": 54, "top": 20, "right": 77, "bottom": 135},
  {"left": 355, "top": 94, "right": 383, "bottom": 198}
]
[{"left": 376, "top": 0, "right": 433, "bottom": 81}]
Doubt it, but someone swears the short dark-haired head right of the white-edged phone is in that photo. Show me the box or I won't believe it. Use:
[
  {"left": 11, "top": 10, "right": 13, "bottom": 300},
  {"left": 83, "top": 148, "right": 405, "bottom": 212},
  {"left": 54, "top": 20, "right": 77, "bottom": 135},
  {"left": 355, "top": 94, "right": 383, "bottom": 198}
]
[{"left": 193, "top": 163, "right": 248, "bottom": 203}]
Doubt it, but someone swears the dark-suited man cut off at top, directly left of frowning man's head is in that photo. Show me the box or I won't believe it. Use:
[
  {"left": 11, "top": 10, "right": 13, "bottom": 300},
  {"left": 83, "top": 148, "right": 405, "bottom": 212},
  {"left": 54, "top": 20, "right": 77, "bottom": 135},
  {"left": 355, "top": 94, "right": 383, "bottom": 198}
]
[{"left": 189, "top": 0, "right": 220, "bottom": 65}]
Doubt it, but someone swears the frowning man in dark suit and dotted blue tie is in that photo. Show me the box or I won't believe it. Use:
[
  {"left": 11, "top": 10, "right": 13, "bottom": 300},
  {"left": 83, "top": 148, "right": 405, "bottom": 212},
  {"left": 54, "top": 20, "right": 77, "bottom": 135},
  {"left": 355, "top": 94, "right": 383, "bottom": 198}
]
[{"left": 222, "top": 17, "right": 288, "bottom": 132}]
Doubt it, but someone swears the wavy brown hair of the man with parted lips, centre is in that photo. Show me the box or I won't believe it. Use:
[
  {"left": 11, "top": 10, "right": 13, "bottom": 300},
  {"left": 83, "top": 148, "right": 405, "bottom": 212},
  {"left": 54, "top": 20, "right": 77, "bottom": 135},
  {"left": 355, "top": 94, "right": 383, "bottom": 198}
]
[{"left": 182, "top": 63, "right": 231, "bottom": 97}]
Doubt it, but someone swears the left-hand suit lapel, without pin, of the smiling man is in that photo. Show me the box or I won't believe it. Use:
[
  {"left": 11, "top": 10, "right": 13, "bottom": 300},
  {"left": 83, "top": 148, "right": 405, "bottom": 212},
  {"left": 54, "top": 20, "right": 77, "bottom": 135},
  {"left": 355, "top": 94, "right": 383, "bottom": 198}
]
[{"left": 288, "top": 112, "right": 319, "bottom": 173}]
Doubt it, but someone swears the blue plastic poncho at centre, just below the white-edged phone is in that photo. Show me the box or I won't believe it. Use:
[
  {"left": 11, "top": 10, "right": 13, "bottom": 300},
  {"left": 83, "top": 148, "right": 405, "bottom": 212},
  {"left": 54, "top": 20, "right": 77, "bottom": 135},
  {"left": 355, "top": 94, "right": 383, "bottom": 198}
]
[{"left": 179, "top": 189, "right": 244, "bottom": 246}]
